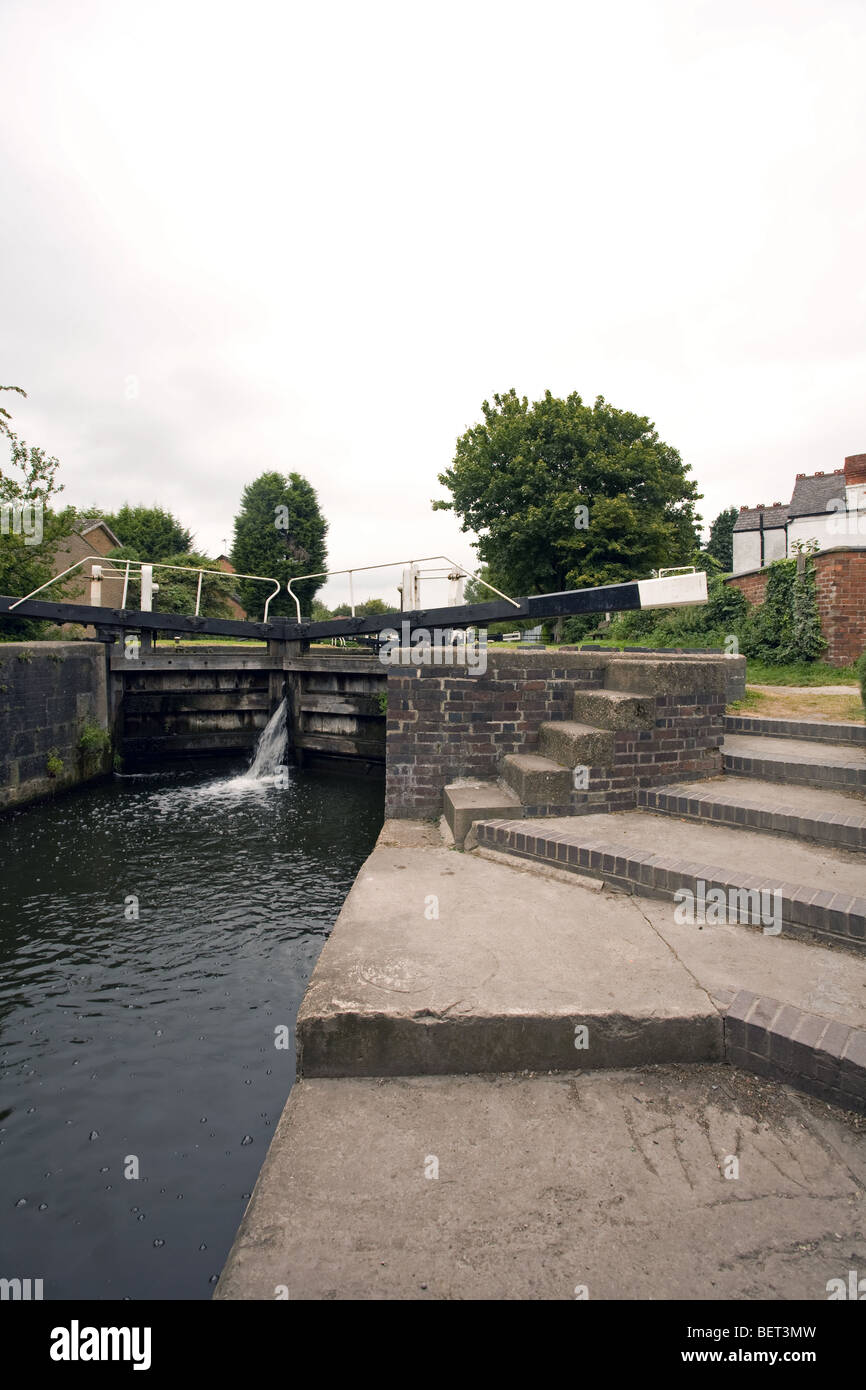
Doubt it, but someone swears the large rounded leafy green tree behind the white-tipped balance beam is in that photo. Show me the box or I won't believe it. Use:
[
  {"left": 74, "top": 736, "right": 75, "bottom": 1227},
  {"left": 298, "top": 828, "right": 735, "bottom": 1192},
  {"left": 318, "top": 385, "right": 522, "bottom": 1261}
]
[{"left": 434, "top": 389, "right": 699, "bottom": 595}]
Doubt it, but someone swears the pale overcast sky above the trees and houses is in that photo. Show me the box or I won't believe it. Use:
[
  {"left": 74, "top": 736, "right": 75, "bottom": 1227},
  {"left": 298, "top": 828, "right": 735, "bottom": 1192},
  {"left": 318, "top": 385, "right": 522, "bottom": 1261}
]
[{"left": 0, "top": 0, "right": 866, "bottom": 600}]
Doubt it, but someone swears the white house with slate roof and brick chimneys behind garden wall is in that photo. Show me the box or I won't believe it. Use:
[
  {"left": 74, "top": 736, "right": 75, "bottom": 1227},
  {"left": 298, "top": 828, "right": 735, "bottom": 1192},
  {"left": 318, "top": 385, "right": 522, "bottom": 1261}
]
[{"left": 731, "top": 453, "right": 866, "bottom": 574}]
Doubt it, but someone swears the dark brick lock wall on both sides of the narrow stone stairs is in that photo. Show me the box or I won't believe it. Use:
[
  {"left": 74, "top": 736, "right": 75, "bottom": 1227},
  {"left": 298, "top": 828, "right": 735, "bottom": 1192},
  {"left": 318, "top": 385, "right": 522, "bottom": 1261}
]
[{"left": 385, "top": 652, "right": 727, "bottom": 817}]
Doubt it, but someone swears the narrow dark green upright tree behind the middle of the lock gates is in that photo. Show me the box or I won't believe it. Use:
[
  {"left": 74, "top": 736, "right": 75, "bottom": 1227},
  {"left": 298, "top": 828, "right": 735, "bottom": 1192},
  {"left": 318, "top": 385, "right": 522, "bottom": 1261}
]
[{"left": 231, "top": 473, "right": 328, "bottom": 617}]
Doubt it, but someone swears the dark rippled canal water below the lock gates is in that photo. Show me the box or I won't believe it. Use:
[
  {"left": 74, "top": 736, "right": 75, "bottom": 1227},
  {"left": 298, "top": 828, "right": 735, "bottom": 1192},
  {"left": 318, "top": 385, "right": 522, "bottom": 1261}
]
[{"left": 0, "top": 759, "right": 382, "bottom": 1298}]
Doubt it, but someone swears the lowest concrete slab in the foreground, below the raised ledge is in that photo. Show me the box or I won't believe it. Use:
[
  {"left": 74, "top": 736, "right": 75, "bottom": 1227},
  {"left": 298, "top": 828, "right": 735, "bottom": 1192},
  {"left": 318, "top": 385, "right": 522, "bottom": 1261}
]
[{"left": 214, "top": 1066, "right": 866, "bottom": 1301}]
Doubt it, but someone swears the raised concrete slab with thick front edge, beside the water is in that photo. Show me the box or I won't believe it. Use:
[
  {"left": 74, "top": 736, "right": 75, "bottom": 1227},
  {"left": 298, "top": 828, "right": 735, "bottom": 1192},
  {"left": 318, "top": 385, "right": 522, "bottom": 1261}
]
[{"left": 297, "top": 848, "right": 721, "bottom": 1076}]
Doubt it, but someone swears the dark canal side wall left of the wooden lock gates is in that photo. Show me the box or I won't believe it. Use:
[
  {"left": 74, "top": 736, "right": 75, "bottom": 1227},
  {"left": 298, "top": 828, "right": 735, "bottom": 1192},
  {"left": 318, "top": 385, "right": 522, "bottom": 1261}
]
[{"left": 0, "top": 642, "right": 111, "bottom": 810}]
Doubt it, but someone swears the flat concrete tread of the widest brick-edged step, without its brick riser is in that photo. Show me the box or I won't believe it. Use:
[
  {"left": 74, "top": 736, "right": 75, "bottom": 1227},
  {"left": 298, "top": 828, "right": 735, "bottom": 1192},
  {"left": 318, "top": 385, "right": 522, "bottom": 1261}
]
[{"left": 483, "top": 810, "right": 866, "bottom": 912}]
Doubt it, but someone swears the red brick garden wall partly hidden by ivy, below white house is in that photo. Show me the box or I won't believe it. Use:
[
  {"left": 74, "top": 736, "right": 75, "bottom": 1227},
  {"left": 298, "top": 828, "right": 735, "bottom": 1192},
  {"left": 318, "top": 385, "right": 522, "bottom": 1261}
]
[{"left": 726, "top": 546, "right": 866, "bottom": 666}]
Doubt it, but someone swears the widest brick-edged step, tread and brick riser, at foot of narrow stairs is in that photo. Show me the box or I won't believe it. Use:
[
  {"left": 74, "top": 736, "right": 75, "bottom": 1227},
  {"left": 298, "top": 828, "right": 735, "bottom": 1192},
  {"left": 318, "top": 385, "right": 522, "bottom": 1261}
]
[{"left": 475, "top": 812, "right": 866, "bottom": 949}]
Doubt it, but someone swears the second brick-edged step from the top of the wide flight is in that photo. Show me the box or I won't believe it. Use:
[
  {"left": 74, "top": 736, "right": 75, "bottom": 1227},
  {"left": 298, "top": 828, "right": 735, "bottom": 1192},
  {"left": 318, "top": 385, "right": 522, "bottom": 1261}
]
[{"left": 721, "top": 734, "right": 866, "bottom": 796}]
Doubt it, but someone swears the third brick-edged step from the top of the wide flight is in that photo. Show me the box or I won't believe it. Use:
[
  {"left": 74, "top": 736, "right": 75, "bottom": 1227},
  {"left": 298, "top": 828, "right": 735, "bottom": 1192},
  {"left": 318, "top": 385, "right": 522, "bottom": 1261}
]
[{"left": 638, "top": 777, "right": 866, "bottom": 851}]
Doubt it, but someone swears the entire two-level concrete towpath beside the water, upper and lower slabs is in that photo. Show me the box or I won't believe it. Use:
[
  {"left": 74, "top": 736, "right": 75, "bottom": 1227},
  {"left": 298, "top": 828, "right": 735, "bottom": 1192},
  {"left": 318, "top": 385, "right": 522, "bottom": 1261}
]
[{"left": 215, "top": 821, "right": 866, "bottom": 1298}]
